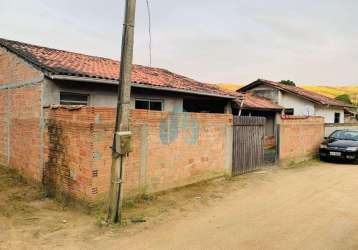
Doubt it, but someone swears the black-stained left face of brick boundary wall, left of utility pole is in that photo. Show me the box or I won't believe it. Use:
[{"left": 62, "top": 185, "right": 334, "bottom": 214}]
[{"left": 44, "top": 109, "right": 94, "bottom": 199}]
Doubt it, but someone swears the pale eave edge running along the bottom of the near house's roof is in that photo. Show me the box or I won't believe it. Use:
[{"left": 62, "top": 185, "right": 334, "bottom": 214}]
[{"left": 46, "top": 74, "right": 237, "bottom": 100}]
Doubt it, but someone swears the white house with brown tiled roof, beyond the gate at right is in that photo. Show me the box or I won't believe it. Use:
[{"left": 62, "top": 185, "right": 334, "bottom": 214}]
[{"left": 238, "top": 79, "right": 355, "bottom": 123}]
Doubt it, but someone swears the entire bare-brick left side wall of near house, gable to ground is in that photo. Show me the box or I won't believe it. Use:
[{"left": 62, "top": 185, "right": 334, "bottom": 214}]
[{"left": 0, "top": 48, "right": 43, "bottom": 181}]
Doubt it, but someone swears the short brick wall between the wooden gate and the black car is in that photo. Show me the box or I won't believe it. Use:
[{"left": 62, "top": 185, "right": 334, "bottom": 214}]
[{"left": 280, "top": 117, "right": 324, "bottom": 163}]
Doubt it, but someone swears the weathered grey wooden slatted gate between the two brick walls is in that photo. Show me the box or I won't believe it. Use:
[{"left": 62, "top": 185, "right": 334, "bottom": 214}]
[{"left": 232, "top": 116, "right": 266, "bottom": 175}]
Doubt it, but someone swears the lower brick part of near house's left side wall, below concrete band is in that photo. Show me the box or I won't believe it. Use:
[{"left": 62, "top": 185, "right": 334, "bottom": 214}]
[{"left": 0, "top": 84, "right": 42, "bottom": 181}]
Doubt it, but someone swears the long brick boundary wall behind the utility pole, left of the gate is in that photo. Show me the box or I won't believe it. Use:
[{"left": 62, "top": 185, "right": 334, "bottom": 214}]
[{"left": 45, "top": 108, "right": 232, "bottom": 200}]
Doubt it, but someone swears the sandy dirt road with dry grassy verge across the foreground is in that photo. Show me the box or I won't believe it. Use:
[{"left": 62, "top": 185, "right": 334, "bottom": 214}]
[{"left": 0, "top": 163, "right": 358, "bottom": 249}]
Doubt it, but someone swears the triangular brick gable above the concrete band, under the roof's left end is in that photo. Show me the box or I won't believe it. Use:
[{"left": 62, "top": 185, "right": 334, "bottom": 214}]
[{"left": 0, "top": 48, "right": 42, "bottom": 84}]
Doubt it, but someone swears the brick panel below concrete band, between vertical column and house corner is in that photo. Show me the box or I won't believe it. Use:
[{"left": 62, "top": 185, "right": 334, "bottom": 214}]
[{"left": 9, "top": 84, "right": 42, "bottom": 181}]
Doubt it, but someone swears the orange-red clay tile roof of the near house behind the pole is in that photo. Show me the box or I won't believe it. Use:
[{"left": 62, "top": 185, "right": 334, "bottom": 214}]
[{"left": 0, "top": 39, "right": 233, "bottom": 98}]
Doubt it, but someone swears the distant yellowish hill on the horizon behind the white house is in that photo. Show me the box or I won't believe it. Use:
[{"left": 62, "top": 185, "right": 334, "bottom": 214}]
[{"left": 218, "top": 83, "right": 358, "bottom": 105}]
